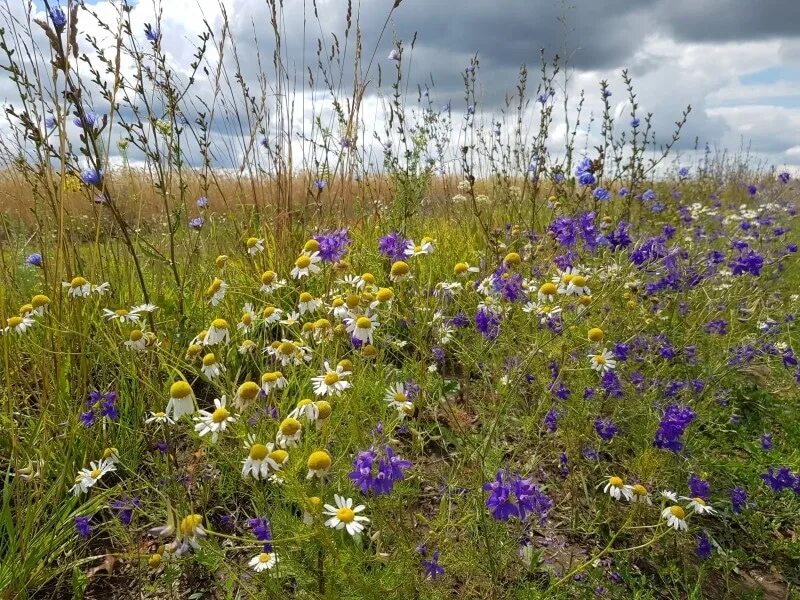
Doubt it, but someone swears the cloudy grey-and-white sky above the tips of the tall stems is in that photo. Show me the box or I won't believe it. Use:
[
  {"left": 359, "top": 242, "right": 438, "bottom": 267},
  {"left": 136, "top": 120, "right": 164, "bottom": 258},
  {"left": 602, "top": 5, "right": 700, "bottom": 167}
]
[{"left": 10, "top": 0, "right": 800, "bottom": 171}]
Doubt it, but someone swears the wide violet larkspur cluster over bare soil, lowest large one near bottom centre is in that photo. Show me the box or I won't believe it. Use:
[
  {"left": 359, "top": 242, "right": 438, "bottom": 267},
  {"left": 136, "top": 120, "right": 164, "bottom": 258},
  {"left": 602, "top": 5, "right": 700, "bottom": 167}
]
[{"left": 483, "top": 469, "right": 553, "bottom": 525}]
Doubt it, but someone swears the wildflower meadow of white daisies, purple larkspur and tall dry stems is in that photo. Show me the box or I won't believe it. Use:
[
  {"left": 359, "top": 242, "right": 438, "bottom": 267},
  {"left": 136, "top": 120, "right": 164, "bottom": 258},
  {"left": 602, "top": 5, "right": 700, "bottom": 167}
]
[{"left": 0, "top": 0, "right": 800, "bottom": 600}]
